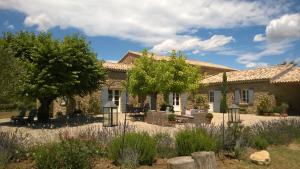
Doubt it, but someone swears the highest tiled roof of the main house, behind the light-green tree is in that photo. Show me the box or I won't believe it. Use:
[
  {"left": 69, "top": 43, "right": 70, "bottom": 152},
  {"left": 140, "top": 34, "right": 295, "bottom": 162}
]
[{"left": 119, "top": 51, "right": 235, "bottom": 71}]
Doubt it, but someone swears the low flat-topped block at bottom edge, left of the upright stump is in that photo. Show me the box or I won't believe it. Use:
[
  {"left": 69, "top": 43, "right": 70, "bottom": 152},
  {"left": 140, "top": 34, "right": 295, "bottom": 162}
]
[{"left": 167, "top": 156, "right": 196, "bottom": 169}]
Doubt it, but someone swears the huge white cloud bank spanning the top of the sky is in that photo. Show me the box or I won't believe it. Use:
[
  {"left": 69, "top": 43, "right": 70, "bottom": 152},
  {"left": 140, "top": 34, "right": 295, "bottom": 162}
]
[{"left": 0, "top": 0, "right": 284, "bottom": 46}]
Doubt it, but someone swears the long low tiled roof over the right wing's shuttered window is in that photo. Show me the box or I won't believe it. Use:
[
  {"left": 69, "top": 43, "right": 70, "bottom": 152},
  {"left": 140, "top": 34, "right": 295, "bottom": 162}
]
[{"left": 202, "top": 64, "right": 294, "bottom": 84}]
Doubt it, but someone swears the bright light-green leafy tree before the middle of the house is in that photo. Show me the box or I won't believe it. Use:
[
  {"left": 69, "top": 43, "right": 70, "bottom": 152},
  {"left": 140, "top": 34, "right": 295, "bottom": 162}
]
[{"left": 128, "top": 50, "right": 202, "bottom": 108}]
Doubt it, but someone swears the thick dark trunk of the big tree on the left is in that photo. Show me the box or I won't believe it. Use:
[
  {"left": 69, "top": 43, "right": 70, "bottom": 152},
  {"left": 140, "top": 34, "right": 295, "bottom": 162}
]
[{"left": 37, "top": 98, "right": 53, "bottom": 123}]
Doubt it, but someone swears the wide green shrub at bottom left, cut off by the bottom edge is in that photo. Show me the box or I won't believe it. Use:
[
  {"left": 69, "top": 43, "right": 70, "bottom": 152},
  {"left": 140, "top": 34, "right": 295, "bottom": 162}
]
[{"left": 34, "top": 139, "right": 101, "bottom": 169}]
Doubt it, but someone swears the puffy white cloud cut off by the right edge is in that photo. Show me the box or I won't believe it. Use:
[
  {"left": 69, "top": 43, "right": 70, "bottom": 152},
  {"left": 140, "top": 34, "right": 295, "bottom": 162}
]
[{"left": 266, "top": 13, "right": 300, "bottom": 42}]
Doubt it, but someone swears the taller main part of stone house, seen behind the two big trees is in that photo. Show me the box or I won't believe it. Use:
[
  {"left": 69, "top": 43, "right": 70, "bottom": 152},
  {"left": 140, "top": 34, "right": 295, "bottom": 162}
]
[{"left": 51, "top": 51, "right": 234, "bottom": 116}]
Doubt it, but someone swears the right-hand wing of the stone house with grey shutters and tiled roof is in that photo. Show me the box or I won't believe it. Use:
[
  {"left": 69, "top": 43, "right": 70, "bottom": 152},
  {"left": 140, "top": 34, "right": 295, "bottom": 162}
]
[{"left": 200, "top": 64, "right": 300, "bottom": 115}]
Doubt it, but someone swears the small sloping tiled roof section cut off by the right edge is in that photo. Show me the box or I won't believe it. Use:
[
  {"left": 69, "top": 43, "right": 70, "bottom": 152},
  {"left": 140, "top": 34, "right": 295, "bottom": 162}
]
[{"left": 272, "top": 67, "right": 300, "bottom": 83}]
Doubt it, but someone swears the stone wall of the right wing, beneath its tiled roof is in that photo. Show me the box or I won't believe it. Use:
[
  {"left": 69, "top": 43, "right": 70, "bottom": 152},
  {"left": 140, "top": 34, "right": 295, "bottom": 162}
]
[{"left": 200, "top": 81, "right": 300, "bottom": 114}]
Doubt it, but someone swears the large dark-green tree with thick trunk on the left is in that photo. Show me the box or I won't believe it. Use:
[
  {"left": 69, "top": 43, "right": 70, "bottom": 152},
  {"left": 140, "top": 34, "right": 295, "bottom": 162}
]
[{"left": 4, "top": 32, "right": 106, "bottom": 122}]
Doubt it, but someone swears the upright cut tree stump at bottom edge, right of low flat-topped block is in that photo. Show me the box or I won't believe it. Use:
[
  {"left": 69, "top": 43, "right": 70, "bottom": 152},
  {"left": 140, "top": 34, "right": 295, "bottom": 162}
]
[{"left": 192, "top": 151, "right": 217, "bottom": 169}]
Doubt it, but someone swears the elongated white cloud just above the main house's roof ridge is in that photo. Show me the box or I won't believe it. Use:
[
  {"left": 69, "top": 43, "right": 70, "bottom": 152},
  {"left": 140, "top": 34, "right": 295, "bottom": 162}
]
[{"left": 151, "top": 35, "right": 234, "bottom": 54}]
